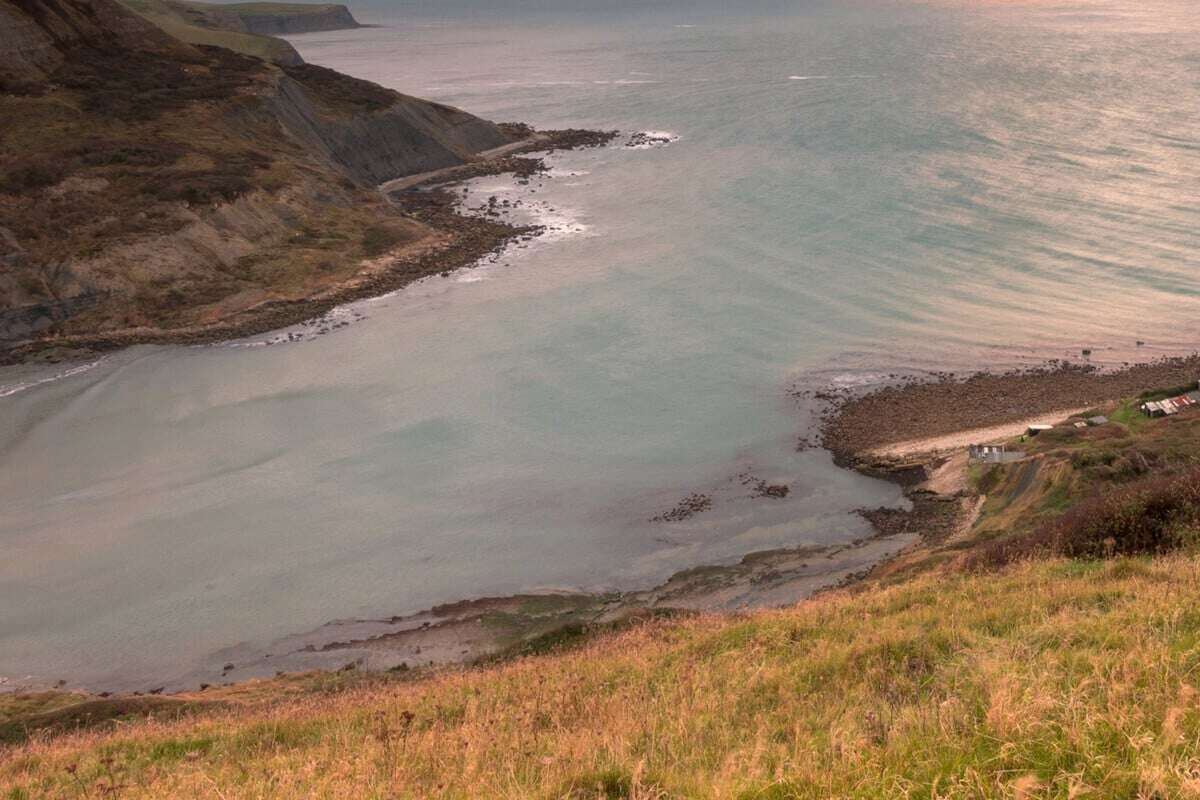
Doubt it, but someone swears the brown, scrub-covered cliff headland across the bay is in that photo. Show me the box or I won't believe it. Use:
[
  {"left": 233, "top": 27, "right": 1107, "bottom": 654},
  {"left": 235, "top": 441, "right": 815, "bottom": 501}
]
[{"left": 0, "top": 0, "right": 509, "bottom": 344}]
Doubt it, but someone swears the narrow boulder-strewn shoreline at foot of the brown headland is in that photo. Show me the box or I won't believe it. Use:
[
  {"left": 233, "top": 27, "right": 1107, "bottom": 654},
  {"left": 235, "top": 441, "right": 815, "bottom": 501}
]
[{"left": 0, "top": 124, "right": 620, "bottom": 367}]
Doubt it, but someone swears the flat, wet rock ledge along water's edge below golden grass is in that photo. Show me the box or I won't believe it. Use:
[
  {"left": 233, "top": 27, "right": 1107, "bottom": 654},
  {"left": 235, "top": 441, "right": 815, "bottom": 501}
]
[{"left": 174, "top": 530, "right": 917, "bottom": 693}]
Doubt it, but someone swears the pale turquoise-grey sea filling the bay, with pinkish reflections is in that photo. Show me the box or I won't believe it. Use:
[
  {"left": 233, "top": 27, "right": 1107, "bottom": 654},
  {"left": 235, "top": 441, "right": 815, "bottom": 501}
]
[{"left": 0, "top": 0, "right": 1200, "bottom": 685}]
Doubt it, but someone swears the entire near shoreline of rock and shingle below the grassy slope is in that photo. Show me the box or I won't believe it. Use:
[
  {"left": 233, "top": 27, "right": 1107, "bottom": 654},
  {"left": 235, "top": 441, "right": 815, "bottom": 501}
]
[{"left": 9, "top": 356, "right": 1200, "bottom": 696}]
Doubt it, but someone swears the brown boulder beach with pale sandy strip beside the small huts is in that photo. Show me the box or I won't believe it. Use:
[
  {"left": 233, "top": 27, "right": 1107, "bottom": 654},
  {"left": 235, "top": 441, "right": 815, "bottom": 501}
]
[{"left": 815, "top": 355, "right": 1200, "bottom": 592}]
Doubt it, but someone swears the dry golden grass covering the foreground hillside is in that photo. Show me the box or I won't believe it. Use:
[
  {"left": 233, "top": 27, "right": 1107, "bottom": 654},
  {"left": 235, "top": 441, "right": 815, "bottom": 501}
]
[{"left": 7, "top": 555, "right": 1200, "bottom": 800}]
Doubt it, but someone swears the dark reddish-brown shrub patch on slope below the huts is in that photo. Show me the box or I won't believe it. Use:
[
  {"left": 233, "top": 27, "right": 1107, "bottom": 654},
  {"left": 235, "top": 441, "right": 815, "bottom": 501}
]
[{"left": 972, "top": 469, "right": 1200, "bottom": 569}]
